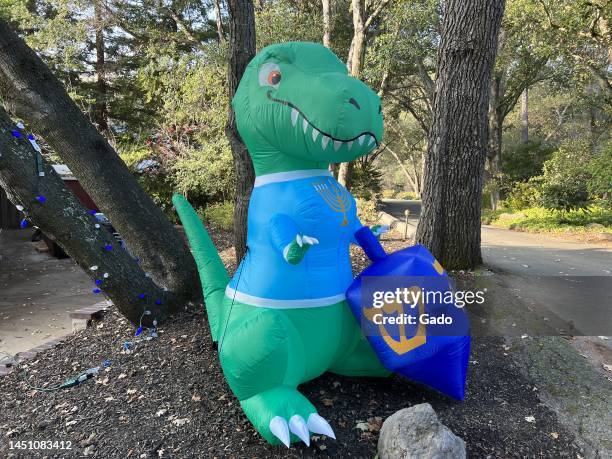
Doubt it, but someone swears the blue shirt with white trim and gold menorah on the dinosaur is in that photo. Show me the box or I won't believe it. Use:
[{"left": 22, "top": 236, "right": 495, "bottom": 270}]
[{"left": 226, "top": 169, "right": 362, "bottom": 308}]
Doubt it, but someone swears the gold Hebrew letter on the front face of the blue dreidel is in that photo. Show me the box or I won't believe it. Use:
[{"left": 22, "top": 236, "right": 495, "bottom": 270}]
[{"left": 363, "top": 286, "right": 427, "bottom": 355}]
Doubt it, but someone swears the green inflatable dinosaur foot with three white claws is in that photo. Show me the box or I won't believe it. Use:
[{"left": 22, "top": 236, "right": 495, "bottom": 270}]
[{"left": 241, "top": 386, "right": 336, "bottom": 447}]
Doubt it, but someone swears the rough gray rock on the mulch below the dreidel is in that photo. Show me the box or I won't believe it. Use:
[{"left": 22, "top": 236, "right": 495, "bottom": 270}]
[{"left": 378, "top": 403, "right": 465, "bottom": 459}]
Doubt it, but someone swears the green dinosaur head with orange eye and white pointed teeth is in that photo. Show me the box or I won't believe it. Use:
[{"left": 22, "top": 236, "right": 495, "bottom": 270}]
[{"left": 232, "top": 42, "right": 383, "bottom": 175}]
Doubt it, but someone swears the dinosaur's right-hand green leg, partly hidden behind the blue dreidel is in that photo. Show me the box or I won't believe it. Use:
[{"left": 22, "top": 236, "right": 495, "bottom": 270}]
[{"left": 329, "top": 306, "right": 391, "bottom": 377}]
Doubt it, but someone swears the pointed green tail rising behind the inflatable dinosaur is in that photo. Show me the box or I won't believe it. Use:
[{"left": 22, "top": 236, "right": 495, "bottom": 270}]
[{"left": 172, "top": 194, "right": 229, "bottom": 341}]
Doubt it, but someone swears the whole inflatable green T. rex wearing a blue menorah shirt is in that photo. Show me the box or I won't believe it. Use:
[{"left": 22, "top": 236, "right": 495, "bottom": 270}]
[{"left": 173, "top": 43, "right": 389, "bottom": 446}]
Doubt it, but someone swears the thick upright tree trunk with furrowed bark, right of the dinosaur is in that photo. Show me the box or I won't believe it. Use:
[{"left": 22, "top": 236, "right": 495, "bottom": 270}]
[{"left": 416, "top": 0, "right": 504, "bottom": 269}]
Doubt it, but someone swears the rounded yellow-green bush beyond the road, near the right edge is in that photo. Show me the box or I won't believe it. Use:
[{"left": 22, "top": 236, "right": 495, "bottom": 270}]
[{"left": 539, "top": 140, "right": 590, "bottom": 210}]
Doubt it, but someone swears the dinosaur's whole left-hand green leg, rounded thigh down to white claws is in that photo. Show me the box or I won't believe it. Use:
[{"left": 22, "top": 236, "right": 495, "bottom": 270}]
[{"left": 220, "top": 308, "right": 334, "bottom": 446}]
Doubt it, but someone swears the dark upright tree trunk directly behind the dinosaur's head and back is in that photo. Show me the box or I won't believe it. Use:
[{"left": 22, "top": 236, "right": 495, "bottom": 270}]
[{"left": 225, "top": 0, "right": 255, "bottom": 260}]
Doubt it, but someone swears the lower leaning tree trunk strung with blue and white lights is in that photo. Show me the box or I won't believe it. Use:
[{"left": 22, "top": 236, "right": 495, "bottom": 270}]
[{"left": 0, "top": 108, "right": 167, "bottom": 323}]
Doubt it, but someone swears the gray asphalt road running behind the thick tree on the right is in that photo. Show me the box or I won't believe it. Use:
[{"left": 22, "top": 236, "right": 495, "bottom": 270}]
[{"left": 383, "top": 200, "right": 612, "bottom": 336}]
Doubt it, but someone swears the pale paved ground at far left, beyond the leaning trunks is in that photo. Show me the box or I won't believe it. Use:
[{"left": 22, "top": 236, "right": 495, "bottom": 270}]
[{"left": 0, "top": 229, "right": 95, "bottom": 354}]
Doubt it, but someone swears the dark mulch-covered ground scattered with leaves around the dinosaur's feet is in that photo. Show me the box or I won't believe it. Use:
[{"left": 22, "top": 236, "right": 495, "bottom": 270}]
[{"left": 0, "top": 236, "right": 584, "bottom": 458}]
